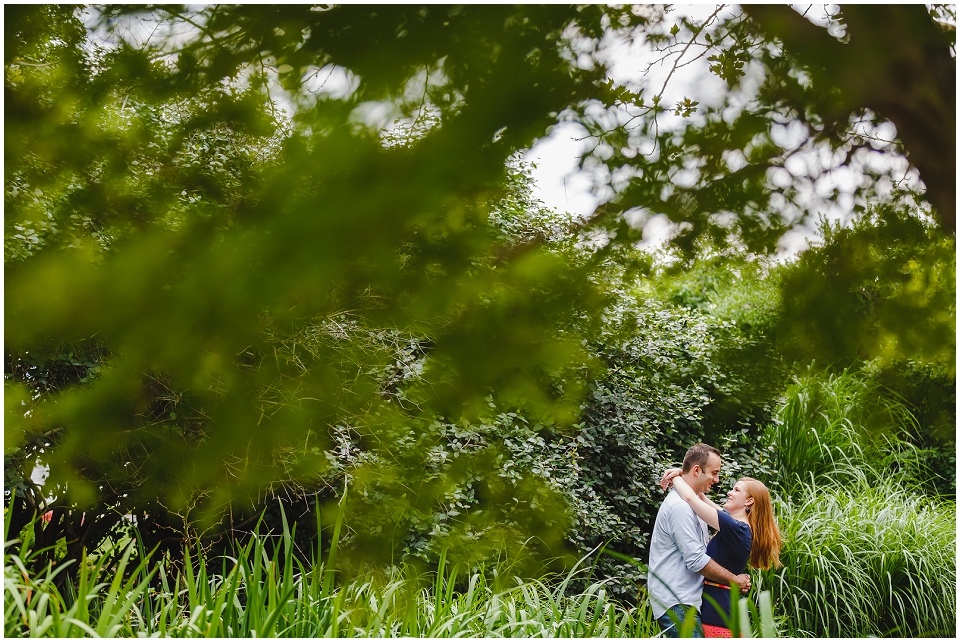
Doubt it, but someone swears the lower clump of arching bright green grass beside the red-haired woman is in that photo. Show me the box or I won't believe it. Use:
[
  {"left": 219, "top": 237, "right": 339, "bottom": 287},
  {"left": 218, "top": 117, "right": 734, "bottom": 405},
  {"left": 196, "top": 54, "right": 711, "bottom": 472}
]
[{"left": 759, "top": 480, "right": 957, "bottom": 637}]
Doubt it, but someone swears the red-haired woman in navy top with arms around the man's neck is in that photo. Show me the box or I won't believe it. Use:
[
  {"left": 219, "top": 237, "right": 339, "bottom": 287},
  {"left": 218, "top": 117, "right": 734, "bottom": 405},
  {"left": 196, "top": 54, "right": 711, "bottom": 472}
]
[{"left": 661, "top": 468, "right": 782, "bottom": 638}]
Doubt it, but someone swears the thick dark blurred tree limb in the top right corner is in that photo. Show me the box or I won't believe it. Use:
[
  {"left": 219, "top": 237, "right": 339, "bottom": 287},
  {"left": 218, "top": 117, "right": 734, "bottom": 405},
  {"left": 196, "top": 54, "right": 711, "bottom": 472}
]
[{"left": 743, "top": 5, "right": 957, "bottom": 234}]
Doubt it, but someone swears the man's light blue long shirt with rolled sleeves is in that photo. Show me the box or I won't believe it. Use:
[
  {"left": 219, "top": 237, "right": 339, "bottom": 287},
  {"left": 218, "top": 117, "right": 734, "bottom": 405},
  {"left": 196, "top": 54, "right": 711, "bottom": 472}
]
[{"left": 647, "top": 488, "right": 710, "bottom": 618}]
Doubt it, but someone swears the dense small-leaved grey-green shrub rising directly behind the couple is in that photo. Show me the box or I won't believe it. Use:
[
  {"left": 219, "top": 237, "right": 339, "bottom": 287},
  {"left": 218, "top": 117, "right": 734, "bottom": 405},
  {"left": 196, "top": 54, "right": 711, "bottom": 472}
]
[{"left": 565, "top": 296, "right": 780, "bottom": 591}]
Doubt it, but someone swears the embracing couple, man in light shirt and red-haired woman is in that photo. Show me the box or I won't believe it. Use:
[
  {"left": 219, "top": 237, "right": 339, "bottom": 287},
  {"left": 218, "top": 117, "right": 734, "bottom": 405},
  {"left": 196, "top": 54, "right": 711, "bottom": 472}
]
[{"left": 647, "top": 444, "right": 781, "bottom": 637}]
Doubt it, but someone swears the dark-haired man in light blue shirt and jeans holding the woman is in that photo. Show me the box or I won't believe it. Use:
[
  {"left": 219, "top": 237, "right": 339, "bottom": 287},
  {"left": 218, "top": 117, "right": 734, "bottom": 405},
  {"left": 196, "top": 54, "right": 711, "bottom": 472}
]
[{"left": 647, "top": 444, "right": 750, "bottom": 637}]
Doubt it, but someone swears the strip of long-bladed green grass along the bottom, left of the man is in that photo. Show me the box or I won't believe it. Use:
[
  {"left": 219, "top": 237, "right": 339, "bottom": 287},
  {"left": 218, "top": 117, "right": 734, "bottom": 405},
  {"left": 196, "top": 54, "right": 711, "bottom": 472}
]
[{"left": 4, "top": 516, "right": 657, "bottom": 637}]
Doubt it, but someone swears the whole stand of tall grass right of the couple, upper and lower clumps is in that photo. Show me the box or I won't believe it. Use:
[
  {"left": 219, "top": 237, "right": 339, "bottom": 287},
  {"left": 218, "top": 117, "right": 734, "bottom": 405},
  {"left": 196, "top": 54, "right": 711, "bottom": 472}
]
[{"left": 758, "top": 371, "right": 957, "bottom": 637}]
